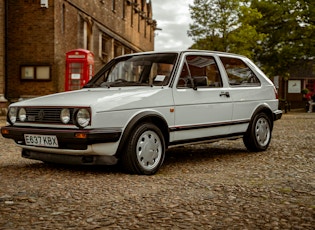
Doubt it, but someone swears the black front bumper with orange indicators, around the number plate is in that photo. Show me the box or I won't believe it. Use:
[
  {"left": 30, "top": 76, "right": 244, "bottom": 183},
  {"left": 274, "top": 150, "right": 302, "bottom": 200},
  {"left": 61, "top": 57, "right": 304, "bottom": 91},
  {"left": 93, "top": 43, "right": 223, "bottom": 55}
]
[{"left": 1, "top": 126, "right": 122, "bottom": 150}]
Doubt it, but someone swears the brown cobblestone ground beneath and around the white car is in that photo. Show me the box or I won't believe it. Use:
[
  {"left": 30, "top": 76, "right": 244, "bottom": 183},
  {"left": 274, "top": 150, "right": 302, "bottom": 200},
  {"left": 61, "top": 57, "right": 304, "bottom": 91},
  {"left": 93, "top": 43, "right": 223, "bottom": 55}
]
[{"left": 0, "top": 111, "right": 315, "bottom": 229}]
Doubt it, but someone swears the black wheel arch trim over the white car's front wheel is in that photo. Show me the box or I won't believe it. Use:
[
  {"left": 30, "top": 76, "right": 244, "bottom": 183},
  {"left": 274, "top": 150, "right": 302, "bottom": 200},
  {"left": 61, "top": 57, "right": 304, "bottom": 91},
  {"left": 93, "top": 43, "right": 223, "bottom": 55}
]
[{"left": 116, "top": 111, "right": 170, "bottom": 156}]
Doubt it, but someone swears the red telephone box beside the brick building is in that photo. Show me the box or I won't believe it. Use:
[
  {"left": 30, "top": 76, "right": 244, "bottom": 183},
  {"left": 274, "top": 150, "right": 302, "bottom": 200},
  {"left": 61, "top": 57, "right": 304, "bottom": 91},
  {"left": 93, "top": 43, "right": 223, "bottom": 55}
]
[{"left": 65, "top": 49, "right": 94, "bottom": 91}]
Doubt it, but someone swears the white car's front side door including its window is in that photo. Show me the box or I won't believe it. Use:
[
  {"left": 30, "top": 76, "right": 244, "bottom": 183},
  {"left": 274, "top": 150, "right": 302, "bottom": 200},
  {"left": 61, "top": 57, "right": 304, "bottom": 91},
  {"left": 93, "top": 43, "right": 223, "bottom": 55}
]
[{"left": 171, "top": 54, "right": 233, "bottom": 142}]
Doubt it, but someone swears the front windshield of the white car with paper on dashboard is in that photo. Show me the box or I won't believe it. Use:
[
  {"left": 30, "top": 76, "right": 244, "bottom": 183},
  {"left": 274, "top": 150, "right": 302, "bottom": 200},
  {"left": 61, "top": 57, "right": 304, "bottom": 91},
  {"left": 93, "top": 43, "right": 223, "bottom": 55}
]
[{"left": 85, "top": 53, "right": 177, "bottom": 88}]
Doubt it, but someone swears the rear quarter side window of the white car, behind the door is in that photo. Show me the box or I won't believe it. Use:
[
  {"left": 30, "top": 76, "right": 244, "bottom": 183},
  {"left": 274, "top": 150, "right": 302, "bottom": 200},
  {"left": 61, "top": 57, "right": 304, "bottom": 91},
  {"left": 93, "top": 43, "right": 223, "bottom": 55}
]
[{"left": 220, "top": 57, "right": 260, "bottom": 87}]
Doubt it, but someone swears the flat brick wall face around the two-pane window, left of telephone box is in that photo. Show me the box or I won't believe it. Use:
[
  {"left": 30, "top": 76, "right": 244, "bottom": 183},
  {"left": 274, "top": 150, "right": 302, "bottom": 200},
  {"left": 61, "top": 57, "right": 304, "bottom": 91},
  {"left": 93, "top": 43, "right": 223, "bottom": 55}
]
[{"left": 6, "top": 0, "right": 56, "bottom": 99}]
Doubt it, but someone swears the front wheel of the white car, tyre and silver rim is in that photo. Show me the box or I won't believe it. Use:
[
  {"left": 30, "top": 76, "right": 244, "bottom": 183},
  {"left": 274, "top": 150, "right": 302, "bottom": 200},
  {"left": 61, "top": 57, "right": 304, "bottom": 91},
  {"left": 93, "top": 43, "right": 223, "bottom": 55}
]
[{"left": 121, "top": 123, "right": 165, "bottom": 175}]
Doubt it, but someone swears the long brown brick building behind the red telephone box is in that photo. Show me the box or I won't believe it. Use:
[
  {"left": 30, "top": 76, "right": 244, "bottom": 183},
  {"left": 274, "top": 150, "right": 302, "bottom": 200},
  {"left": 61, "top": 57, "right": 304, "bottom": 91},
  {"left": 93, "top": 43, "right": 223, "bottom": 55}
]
[{"left": 0, "top": 0, "right": 156, "bottom": 102}]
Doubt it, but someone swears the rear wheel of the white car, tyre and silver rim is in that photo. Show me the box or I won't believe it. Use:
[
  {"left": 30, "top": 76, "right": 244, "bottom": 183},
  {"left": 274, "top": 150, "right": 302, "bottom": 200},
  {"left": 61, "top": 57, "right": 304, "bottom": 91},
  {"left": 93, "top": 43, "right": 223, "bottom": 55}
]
[{"left": 243, "top": 113, "right": 272, "bottom": 152}]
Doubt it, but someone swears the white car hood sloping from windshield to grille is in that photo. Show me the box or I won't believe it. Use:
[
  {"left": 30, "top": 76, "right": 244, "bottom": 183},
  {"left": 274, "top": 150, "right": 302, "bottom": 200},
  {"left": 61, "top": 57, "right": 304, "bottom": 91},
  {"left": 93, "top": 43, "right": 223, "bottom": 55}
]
[{"left": 14, "top": 87, "right": 172, "bottom": 112}]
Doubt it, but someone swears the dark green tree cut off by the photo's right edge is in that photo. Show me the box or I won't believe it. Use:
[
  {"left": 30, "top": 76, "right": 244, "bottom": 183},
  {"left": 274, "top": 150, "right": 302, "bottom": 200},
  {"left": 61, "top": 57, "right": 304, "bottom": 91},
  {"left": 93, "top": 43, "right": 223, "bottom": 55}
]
[{"left": 250, "top": 0, "right": 315, "bottom": 76}]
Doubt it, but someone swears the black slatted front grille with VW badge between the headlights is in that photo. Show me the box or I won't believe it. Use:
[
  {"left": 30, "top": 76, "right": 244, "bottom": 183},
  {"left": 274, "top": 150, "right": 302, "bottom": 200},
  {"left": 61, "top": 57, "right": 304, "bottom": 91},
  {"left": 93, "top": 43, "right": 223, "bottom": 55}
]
[{"left": 19, "top": 108, "right": 74, "bottom": 124}]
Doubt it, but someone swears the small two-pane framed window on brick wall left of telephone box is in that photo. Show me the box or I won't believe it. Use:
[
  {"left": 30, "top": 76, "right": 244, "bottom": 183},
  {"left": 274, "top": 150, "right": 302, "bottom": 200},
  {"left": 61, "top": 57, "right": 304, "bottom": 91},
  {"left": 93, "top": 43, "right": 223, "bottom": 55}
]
[{"left": 21, "top": 65, "right": 51, "bottom": 81}]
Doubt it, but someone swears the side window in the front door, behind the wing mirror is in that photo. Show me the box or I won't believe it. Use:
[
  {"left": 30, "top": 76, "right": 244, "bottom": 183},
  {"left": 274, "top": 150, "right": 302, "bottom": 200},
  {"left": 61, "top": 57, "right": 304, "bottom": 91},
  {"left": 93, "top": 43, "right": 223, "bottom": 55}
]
[{"left": 177, "top": 55, "right": 222, "bottom": 88}]
